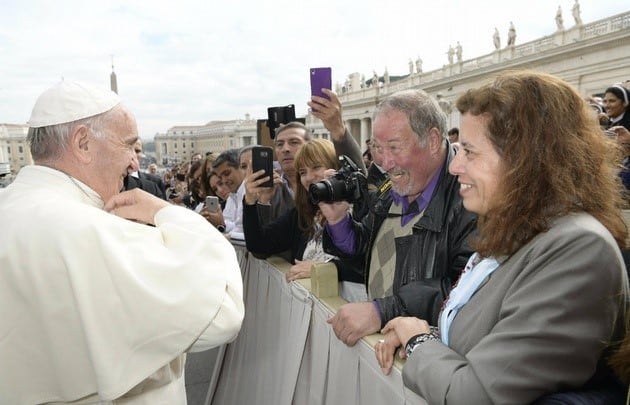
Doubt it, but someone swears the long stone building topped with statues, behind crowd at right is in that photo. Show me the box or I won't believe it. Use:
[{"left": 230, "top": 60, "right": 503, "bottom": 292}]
[{"left": 330, "top": 12, "right": 630, "bottom": 145}]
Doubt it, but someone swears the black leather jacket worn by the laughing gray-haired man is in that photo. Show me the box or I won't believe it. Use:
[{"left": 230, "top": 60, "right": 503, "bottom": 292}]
[{"left": 324, "top": 144, "right": 476, "bottom": 326}]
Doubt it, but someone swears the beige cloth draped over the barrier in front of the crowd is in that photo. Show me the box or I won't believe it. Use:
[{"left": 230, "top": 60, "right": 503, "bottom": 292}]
[{"left": 206, "top": 246, "right": 426, "bottom": 405}]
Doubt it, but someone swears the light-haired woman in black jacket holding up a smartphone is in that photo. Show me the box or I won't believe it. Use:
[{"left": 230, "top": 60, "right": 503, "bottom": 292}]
[{"left": 243, "top": 139, "right": 366, "bottom": 301}]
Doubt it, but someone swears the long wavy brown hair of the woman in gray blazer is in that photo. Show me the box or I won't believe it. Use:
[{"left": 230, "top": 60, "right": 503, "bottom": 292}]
[{"left": 457, "top": 71, "right": 628, "bottom": 257}]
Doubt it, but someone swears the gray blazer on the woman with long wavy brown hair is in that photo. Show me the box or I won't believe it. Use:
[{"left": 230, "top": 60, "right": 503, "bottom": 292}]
[{"left": 403, "top": 214, "right": 628, "bottom": 404}]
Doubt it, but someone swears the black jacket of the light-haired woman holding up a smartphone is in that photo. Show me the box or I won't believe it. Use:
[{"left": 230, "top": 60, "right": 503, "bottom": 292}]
[{"left": 243, "top": 204, "right": 363, "bottom": 283}]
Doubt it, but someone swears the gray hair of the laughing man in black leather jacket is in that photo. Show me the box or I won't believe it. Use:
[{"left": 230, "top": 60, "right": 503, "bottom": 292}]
[{"left": 373, "top": 89, "right": 446, "bottom": 147}]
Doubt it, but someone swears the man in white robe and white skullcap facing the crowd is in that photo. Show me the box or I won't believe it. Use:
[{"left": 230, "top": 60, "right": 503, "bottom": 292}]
[{"left": 0, "top": 81, "right": 244, "bottom": 405}]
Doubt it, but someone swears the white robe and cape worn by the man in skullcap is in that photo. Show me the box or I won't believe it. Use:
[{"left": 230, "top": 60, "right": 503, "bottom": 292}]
[{"left": 0, "top": 166, "right": 244, "bottom": 404}]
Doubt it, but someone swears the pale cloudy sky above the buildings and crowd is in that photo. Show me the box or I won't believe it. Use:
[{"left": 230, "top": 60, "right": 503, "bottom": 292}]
[{"left": 0, "top": 0, "right": 630, "bottom": 139}]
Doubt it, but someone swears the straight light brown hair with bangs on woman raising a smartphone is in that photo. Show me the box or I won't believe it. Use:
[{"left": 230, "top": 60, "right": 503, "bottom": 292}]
[{"left": 293, "top": 139, "right": 339, "bottom": 238}]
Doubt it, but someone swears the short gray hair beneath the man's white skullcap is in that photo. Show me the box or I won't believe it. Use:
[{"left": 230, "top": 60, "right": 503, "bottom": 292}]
[{"left": 26, "top": 104, "right": 124, "bottom": 161}]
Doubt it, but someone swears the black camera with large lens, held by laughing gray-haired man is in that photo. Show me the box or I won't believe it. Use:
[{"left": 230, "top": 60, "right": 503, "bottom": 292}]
[{"left": 308, "top": 155, "right": 367, "bottom": 205}]
